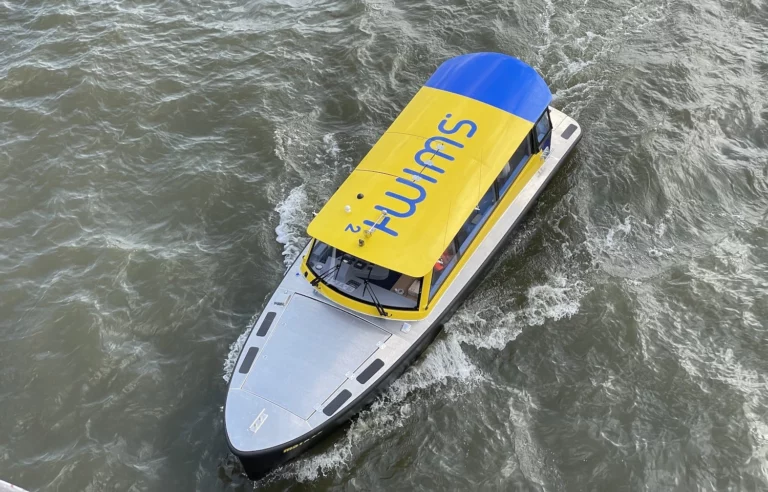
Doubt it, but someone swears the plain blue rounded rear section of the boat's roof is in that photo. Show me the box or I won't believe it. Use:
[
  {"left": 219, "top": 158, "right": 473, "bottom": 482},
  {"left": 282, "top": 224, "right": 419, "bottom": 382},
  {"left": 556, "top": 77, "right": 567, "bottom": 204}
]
[{"left": 426, "top": 53, "right": 552, "bottom": 122}]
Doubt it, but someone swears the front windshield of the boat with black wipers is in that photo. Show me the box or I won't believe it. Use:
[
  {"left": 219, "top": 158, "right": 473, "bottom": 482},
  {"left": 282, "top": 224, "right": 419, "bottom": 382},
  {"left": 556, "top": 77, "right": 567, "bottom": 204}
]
[{"left": 307, "top": 240, "right": 421, "bottom": 315}]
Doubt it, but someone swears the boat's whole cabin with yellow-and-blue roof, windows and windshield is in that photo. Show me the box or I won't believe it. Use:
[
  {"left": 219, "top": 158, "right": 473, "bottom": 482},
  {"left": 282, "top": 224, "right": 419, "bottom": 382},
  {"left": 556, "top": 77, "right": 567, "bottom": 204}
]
[{"left": 301, "top": 54, "right": 552, "bottom": 320}]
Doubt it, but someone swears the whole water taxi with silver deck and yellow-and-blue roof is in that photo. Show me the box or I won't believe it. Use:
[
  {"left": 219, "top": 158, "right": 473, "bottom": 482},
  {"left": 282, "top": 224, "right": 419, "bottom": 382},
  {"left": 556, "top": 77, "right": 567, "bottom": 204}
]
[{"left": 224, "top": 53, "right": 581, "bottom": 479}]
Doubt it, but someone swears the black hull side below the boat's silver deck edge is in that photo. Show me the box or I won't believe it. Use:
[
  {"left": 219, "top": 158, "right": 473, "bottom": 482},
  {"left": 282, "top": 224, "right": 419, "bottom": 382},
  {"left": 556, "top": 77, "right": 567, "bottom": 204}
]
[{"left": 227, "top": 136, "right": 581, "bottom": 480}]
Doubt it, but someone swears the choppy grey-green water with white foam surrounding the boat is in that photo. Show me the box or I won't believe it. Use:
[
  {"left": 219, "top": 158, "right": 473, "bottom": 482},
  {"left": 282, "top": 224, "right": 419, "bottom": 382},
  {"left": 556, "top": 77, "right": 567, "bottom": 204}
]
[{"left": 0, "top": 0, "right": 768, "bottom": 491}]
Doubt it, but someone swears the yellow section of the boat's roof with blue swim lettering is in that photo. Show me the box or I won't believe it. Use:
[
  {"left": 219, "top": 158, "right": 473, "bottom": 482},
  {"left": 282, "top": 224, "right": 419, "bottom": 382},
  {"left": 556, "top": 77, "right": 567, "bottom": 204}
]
[{"left": 307, "top": 87, "right": 533, "bottom": 277}]
